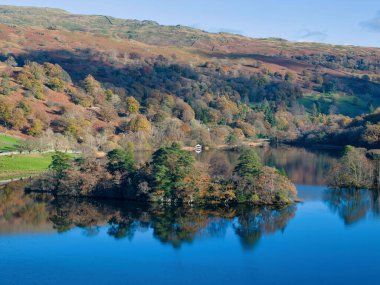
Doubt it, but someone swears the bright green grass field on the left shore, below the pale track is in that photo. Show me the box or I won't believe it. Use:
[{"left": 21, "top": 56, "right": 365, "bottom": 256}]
[{"left": 0, "top": 153, "right": 52, "bottom": 181}]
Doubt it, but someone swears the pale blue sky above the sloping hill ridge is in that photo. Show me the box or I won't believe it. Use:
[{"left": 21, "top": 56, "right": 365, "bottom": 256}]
[{"left": 0, "top": 0, "right": 380, "bottom": 47}]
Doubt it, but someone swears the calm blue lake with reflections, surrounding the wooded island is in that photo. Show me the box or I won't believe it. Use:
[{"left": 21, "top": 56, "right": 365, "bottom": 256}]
[{"left": 0, "top": 147, "right": 380, "bottom": 285}]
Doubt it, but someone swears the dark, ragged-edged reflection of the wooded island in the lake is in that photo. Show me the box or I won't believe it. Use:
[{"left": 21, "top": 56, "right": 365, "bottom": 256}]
[{"left": 49, "top": 199, "right": 296, "bottom": 249}]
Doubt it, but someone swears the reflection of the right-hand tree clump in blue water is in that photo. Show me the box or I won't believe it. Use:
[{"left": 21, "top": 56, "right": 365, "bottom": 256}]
[{"left": 323, "top": 189, "right": 380, "bottom": 225}]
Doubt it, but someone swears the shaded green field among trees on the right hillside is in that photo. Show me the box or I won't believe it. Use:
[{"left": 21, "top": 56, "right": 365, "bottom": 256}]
[{"left": 299, "top": 93, "right": 377, "bottom": 117}]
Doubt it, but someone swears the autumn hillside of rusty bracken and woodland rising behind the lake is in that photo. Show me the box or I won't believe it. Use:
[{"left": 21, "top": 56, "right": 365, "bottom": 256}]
[{"left": 0, "top": 6, "right": 380, "bottom": 151}]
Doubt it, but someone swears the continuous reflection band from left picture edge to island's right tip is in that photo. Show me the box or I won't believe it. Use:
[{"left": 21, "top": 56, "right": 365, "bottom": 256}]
[{"left": 0, "top": 182, "right": 296, "bottom": 249}]
